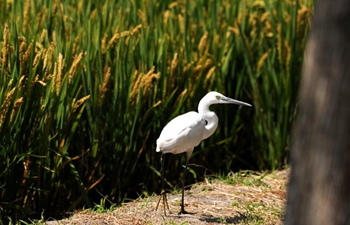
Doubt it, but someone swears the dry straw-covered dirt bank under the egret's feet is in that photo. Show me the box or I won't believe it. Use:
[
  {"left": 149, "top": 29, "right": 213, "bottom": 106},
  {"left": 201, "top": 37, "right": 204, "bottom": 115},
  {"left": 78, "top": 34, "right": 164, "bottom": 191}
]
[{"left": 46, "top": 169, "right": 289, "bottom": 225}]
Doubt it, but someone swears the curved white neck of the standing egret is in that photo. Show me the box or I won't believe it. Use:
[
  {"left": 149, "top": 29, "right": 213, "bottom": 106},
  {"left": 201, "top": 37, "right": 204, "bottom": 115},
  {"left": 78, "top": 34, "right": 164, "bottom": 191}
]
[{"left": 198, "top": 100, "right": 219, "bottom": 139}]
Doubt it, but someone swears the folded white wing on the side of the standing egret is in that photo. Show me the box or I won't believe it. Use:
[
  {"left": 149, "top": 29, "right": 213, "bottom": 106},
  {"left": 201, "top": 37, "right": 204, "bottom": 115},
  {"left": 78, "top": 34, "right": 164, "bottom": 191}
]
[{"left": 157, "top": 112, "right": 206, "bottom": 154}]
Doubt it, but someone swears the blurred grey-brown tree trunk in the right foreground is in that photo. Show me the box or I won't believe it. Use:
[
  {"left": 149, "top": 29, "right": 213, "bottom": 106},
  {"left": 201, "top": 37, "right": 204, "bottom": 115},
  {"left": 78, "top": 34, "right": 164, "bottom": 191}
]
[{"left": 285, "top": 0, "right": 350, "bottom": 225}]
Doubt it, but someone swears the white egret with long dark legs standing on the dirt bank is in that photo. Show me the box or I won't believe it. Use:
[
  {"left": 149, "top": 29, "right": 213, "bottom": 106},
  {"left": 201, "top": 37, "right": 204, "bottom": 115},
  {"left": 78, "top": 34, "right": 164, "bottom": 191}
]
[{"left": 156, "top": 91, "right": 251, "bottom": 215}]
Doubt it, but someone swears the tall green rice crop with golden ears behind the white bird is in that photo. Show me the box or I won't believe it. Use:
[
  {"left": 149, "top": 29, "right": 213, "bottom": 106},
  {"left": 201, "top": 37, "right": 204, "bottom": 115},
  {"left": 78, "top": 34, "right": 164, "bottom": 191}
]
[{"left": 0, "top": 0, "right": 313, "bottom": 220}]
